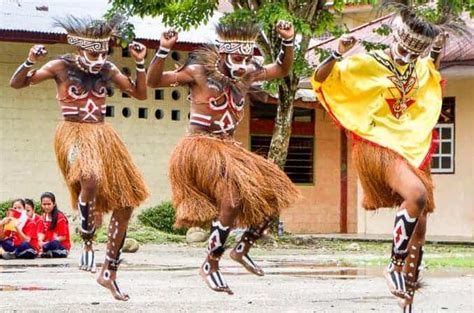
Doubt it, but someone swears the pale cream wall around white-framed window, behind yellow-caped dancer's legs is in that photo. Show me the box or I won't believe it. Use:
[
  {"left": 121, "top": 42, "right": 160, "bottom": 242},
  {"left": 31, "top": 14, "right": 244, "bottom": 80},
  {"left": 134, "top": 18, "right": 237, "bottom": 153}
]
[{"left": 358, "top": 76, "right": 474, "bottom": 238}]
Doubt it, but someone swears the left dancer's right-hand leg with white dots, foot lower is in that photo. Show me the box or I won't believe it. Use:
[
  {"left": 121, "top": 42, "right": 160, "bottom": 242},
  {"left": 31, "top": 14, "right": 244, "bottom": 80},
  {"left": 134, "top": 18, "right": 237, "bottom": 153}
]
[{"left": 97, "top": 208, "right": 132, "bottom": 301}]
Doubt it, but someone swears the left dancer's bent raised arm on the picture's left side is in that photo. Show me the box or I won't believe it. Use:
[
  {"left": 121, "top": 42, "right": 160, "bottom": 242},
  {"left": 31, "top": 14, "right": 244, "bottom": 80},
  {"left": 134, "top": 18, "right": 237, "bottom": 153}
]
[{"left": 10, "top": 45, "right": 57, "bottom": 89}]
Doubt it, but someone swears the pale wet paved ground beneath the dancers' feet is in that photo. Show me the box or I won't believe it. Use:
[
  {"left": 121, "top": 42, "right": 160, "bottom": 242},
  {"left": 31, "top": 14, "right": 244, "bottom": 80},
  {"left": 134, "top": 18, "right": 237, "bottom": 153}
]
[{"left": 0, "top": 245, "right": 474, "bottom": 312}]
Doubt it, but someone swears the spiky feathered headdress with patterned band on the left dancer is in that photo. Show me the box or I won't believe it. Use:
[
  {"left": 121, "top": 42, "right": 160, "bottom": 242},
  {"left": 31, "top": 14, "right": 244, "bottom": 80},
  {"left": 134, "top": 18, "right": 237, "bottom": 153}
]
[{"left": 54, "top": 14, "right": 125, "bottom": 52}]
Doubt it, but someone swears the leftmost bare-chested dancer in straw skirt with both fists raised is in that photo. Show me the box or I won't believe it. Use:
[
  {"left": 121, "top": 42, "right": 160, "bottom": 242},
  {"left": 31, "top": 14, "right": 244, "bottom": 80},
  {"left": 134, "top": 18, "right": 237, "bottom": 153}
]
[{"left": 10, "top": 16, "right": 148, "bottom": 300}]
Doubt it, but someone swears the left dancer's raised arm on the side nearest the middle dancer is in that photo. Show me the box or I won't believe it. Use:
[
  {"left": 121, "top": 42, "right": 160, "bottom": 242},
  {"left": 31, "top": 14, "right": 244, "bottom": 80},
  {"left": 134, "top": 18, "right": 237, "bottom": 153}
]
[{"left": 112, "top": 42, "right": 147, "bottom": 100}]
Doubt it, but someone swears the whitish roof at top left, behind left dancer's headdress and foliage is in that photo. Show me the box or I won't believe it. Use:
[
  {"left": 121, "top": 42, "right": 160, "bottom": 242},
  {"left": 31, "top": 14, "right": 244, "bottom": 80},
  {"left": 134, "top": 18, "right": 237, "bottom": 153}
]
[{"left": 0, "top": 0, "right": 222, "bottom": 44}]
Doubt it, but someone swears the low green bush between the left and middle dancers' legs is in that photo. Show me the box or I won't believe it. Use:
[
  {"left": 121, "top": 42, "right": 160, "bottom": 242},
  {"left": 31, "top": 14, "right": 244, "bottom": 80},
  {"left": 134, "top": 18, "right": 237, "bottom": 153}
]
[{"left": 138, "top": 201, "right": 186, "bottom": 235}]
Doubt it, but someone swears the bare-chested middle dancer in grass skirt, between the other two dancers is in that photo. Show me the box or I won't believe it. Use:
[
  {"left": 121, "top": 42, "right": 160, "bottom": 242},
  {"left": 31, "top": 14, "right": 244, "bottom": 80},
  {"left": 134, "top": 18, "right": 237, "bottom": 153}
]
[{"left": 147, "top": 21, "right": 298, "bottom": 294}]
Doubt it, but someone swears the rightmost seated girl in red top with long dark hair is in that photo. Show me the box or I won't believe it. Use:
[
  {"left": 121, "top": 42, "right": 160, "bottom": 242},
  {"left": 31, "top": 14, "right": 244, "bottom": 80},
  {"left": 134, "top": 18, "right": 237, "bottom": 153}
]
[{"left": 39, "top": 192, "right": 71, "bottom": 258}]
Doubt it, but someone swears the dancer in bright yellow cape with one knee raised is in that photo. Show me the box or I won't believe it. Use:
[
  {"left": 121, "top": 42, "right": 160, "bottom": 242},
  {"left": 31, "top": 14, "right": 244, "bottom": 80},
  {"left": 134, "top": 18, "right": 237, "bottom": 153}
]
[{"left": 312, "top": 5, "right": 464, "bottom": 312}]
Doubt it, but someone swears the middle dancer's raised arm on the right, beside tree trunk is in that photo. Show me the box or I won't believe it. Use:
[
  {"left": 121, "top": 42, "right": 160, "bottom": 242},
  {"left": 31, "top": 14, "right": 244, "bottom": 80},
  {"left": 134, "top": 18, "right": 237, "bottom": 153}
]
[{"left": 255, "top": 21, "right": 295, "bottom": 81}]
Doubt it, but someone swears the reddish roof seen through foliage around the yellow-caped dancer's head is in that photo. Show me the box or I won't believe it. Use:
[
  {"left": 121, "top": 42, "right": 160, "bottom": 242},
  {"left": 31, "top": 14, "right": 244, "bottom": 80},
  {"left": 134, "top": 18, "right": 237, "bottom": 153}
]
[{"left": 308, "top": 15, "right": 474, "bottom": 66}]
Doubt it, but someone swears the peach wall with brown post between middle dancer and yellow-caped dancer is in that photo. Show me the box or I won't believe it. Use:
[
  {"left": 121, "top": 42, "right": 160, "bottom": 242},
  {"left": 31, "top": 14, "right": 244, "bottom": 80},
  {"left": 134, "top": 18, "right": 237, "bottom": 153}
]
[{"left": 281, "top": 109, "right": 357, "bottom": 233}]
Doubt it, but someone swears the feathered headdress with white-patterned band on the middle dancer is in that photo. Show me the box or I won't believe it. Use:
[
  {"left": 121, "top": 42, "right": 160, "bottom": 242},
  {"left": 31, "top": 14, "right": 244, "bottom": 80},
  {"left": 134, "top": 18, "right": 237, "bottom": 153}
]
[{"left": 216, "top": 23, "right": 260, "bottom": 55}]
